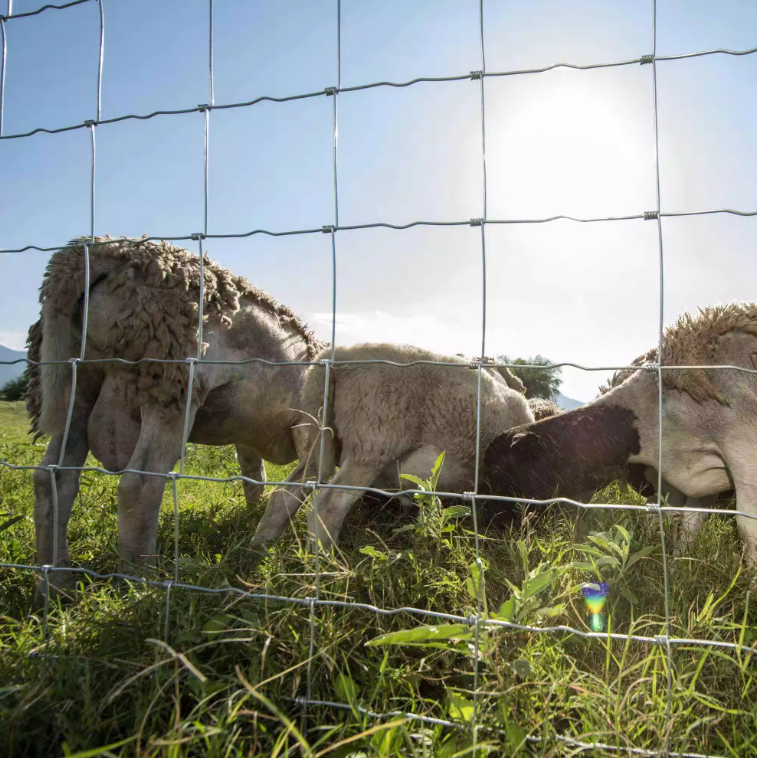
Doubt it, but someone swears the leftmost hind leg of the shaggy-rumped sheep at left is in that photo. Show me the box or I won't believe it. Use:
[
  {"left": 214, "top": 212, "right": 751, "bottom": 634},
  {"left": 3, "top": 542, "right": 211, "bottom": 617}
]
[{"left": 33, "top": 410, "right": 90, "bottom": 589}]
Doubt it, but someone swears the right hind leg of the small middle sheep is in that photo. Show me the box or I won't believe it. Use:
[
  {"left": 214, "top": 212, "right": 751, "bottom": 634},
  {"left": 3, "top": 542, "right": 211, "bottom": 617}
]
[{"left": 308, "top": 460, "right": 385, "bottom": 547}]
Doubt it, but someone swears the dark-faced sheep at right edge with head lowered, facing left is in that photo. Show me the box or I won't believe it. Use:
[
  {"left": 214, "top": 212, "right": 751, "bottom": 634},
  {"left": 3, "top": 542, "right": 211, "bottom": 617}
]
[{"left": 484, "top": 303, "right": 757, "bottom": 560}]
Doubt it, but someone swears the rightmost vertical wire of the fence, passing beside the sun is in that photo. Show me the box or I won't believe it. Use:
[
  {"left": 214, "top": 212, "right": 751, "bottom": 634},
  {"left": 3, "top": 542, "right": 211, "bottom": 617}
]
[{"left": 652, "top": 0, "right": 673, "bottom": 754}]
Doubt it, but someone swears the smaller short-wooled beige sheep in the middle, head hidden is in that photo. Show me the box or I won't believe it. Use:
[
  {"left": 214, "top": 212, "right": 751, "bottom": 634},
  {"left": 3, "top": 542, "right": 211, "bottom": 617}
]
[{"left": 254, "top": 344, "right": 533, "bottom": 544}]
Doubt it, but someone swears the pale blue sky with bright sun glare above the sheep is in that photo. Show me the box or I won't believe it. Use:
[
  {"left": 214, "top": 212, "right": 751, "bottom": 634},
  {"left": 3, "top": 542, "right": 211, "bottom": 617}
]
[{"left": 0, "top": 0, "right": 757, "bottom": 400}]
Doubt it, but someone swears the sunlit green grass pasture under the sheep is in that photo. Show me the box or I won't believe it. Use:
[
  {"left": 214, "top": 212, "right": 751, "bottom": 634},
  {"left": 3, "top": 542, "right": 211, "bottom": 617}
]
[{"left": 0, "top": 403, "right": 757, "bottom": 758}]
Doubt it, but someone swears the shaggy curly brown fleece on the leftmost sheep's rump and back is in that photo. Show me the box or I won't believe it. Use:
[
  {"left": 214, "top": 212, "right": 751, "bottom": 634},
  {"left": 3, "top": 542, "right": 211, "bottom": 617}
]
[{"left": 27, "top": 237, "right": 323, "bottom": 432}]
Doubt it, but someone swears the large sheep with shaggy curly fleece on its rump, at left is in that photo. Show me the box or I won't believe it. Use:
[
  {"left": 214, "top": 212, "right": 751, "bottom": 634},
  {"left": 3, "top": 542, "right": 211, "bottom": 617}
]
[{"left": 27, "top": 237, "right": 323, "bottom": 586}]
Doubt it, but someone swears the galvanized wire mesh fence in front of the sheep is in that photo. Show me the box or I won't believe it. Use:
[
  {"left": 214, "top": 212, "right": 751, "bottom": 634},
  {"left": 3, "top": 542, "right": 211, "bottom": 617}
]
[{"left": 0, "top": 0, "right": 757, "bottom": 758}]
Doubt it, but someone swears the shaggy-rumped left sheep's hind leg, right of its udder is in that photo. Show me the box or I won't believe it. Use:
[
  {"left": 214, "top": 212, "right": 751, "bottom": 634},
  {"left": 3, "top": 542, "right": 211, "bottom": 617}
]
[{"left": 118, "top": 403, "right": 197, "bottom": 574}]
